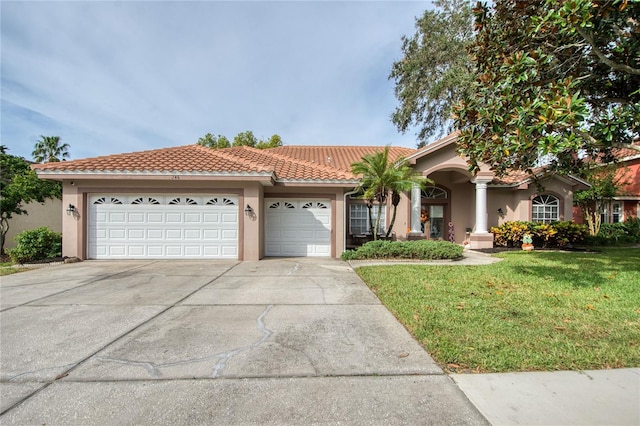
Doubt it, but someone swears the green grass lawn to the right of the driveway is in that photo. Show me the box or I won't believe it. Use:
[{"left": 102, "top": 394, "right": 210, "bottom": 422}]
[{"left": 356, "top": 249, "right": 640, "bottom": 372}]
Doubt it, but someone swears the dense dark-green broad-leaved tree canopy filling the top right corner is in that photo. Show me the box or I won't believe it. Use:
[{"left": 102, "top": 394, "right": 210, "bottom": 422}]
[{"left": 455, "top": 0, "right": 640, "bottom": 175}]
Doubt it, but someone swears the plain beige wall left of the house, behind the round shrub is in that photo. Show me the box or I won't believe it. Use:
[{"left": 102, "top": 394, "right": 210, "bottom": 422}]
[{"left": 4, "top": 198, "right": 62, "bottom": 250}]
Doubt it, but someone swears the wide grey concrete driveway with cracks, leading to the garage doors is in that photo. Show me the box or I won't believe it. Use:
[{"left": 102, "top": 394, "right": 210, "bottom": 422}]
[{"left": 0, "top": 258, "right": 486, "bottom": 425}]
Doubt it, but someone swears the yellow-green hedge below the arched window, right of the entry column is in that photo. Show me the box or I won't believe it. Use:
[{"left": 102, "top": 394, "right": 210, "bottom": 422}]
[{"left": 491, "top": 221, "right": 589, "bottom": 248}]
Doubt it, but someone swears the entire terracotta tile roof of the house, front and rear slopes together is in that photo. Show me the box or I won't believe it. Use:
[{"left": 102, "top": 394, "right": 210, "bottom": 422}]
[{"left": 33, "top": 145, "right": 390, "bottom": 181}]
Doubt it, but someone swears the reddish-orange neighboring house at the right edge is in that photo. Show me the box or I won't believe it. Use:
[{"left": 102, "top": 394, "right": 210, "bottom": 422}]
[{"left": 574, "top": 139, "right": 640, "bottom": 223}]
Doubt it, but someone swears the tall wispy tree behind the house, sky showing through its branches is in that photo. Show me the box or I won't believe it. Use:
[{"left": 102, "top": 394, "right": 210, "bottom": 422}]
[{"left": 389, "top": 0, "right": 475, "bottom": 147}]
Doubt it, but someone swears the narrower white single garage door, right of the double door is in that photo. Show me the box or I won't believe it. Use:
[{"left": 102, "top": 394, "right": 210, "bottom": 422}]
[{"left": 265, "top": 199, "right": 331, "bottom": 256}]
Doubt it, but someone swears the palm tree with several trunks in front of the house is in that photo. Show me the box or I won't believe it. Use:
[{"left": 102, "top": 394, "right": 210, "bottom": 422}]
[{"left": 351, "top": 145, "right": 428, "bottom": 240}]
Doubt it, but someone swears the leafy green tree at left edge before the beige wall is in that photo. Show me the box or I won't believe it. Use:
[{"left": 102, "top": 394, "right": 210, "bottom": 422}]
[{"left": 0, "top": 152, "right": 62, "bottom": 253}]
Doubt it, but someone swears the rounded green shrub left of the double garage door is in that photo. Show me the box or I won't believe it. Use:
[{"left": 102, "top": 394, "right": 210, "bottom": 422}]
[{"left": 8, "top": 226, "right": 62, "bottom": 263}]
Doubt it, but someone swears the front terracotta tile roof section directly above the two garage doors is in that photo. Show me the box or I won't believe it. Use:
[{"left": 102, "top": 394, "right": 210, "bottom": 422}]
[{"left": 33, "top": 145, "right": 370, "bottom": 183}]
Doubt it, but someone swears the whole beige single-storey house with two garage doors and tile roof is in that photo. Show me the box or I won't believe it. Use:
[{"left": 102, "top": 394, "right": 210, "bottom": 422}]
[{"left": 34, "top": 134, "right": 584, "bottom": 260}]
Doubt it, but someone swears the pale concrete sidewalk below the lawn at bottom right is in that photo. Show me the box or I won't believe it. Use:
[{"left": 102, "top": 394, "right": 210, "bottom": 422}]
[{"left": 451, "top": 368, "right": 640, "bottom": 426}]
